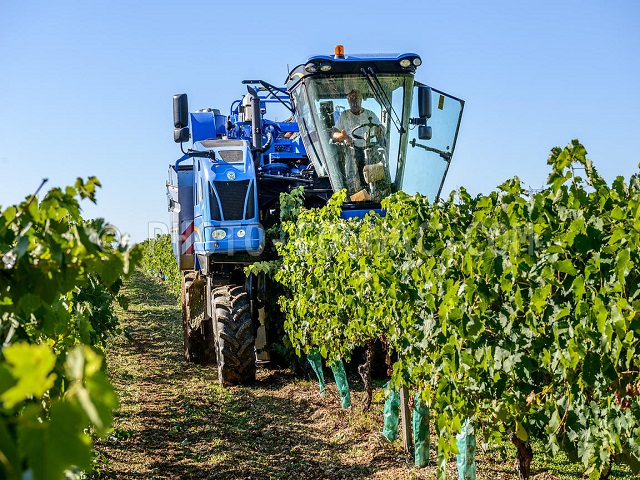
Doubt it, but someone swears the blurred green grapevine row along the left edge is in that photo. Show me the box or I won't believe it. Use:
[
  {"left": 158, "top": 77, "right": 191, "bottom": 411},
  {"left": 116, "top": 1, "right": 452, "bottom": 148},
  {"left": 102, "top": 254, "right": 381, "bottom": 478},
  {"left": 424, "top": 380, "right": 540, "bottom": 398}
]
[{"left": 0, "top": 177, "right": 139, "bottom": 480}]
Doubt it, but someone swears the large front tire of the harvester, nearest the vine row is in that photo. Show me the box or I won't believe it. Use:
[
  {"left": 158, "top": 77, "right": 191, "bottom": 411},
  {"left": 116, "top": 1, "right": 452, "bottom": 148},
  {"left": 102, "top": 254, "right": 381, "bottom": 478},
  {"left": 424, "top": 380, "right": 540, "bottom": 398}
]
[{"left": 211, "top": 285, "right": 256, "bottom": 386}]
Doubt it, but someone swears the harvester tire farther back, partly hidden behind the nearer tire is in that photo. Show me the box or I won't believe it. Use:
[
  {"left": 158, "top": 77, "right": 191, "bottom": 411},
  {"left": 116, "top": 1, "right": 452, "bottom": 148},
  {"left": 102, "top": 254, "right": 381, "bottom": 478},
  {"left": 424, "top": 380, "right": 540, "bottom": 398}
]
[{"left": 181, "top": 272, "right": 216, "bottom": 364}]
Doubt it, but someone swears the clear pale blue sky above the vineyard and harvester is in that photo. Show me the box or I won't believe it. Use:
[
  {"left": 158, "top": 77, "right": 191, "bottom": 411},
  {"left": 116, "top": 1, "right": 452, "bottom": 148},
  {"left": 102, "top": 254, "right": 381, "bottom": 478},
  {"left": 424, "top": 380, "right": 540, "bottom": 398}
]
[{"left": 0, "top": 0, "right": 640, "bottom": 241}]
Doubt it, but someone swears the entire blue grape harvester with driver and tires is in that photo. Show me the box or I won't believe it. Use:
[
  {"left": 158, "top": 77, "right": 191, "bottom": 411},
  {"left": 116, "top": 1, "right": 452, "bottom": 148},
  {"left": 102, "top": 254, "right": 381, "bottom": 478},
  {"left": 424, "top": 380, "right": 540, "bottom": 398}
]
[{"left": 167, "top": 47, "right": 464, "bottom": 384}]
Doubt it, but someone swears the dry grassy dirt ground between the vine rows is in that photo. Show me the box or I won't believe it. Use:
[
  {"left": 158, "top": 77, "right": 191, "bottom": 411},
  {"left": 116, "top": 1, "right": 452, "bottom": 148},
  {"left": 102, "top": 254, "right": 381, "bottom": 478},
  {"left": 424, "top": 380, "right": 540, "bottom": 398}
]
[{"left": 92, "top": 274, "right": 596, "bottom": 480}]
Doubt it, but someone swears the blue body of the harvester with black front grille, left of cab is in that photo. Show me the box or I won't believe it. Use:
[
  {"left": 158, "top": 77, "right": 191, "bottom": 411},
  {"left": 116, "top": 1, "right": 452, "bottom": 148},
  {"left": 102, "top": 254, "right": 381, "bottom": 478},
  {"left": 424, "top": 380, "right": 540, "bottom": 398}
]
[{"left": 167, "top": 88, "right": 309, "bottom": 269}]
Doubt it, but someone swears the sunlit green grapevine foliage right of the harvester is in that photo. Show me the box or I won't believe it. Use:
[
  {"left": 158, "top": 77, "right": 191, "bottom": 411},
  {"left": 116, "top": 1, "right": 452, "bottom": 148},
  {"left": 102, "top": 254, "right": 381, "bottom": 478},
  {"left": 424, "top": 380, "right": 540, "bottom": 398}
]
[{"left": 276, "top": 140, "right": 640, "bottom": 478}]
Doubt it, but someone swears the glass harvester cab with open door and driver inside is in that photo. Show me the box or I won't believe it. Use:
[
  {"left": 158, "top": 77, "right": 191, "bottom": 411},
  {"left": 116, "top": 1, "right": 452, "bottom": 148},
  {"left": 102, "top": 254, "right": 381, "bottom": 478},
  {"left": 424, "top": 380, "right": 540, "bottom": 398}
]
[{"left": 287, "top": 47, "right": 464, "bottom": 211}]
